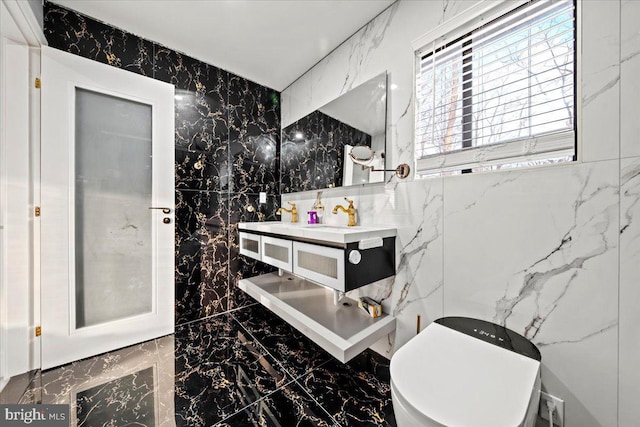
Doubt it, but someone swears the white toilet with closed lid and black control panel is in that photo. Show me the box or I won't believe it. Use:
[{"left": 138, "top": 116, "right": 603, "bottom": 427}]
[{"left": 390, "top": 317, "right": 541, "bottom": 427}]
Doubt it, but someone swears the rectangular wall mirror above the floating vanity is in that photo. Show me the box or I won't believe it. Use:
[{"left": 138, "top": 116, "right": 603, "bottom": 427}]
[{"left": 280, "top": 72, "right": 387, "bottom": 193}]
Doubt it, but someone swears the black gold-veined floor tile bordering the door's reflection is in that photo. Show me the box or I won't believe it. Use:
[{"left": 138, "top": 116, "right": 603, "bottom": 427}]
[{"left": 175, "top": 314, "right": 289, "bottom": 426}]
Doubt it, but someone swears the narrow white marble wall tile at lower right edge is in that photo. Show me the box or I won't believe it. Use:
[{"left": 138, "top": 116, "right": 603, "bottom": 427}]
[{"left": 619, "top": 157, "right": 640, "bottom": 427}]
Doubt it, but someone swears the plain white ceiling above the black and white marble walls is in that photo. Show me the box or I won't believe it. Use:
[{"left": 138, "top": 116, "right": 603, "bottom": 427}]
[{"left": 54, "top": 0, "right": 394, "bottom": 91}]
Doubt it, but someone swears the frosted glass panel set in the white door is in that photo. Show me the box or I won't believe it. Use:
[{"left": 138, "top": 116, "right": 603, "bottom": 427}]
[{"left": 75, "top": 88, "right": 153, "bottom": 328}]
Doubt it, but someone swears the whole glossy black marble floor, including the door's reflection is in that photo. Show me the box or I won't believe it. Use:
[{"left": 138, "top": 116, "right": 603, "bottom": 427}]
[{"left": 6, "top": 304, "right": 395, "bottom": 427}]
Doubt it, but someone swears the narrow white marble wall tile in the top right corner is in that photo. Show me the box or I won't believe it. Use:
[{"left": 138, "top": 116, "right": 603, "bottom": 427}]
[{"left": 620, "top": 0, "right": 640, "bottom": 157}]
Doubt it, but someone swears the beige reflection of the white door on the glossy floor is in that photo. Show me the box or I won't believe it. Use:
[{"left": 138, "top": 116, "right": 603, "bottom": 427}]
[{"left": 14, "top": 335, "right": 175, "bottom": 427}]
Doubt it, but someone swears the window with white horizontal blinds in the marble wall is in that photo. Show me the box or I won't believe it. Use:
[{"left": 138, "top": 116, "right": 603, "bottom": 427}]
[{"left": 415, "top": 0, "right": 576, "bottom": 175}]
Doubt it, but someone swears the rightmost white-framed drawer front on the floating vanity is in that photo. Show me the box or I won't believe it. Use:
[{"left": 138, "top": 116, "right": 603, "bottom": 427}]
[{"left": 293, "top": 242, "right": 345, "bottom": 291}]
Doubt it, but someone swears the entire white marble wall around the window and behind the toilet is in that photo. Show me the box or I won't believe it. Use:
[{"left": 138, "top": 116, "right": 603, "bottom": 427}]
[{"left": 283, "top": 0, "right": 640, "bottom": 427}]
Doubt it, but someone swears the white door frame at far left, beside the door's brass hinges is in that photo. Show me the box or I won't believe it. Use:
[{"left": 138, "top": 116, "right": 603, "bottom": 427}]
[{"left": 0, "top": 0, "right": 47, "bottom": 390}]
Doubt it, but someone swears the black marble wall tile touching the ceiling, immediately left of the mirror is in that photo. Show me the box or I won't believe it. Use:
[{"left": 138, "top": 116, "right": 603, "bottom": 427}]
[{"left": 229, "top": 76, "right": 280, "bottom": 194}]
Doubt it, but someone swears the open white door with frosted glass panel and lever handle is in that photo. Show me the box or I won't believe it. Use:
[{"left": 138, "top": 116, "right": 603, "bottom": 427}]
[{"left": 41, "top": 47, "right": 174, "bottom": 369}]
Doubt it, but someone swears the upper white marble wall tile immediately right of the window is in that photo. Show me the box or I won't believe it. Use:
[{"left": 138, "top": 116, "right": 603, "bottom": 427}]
[{"left": 578, "top": 0, "right": 620, "bottom": 162}]
